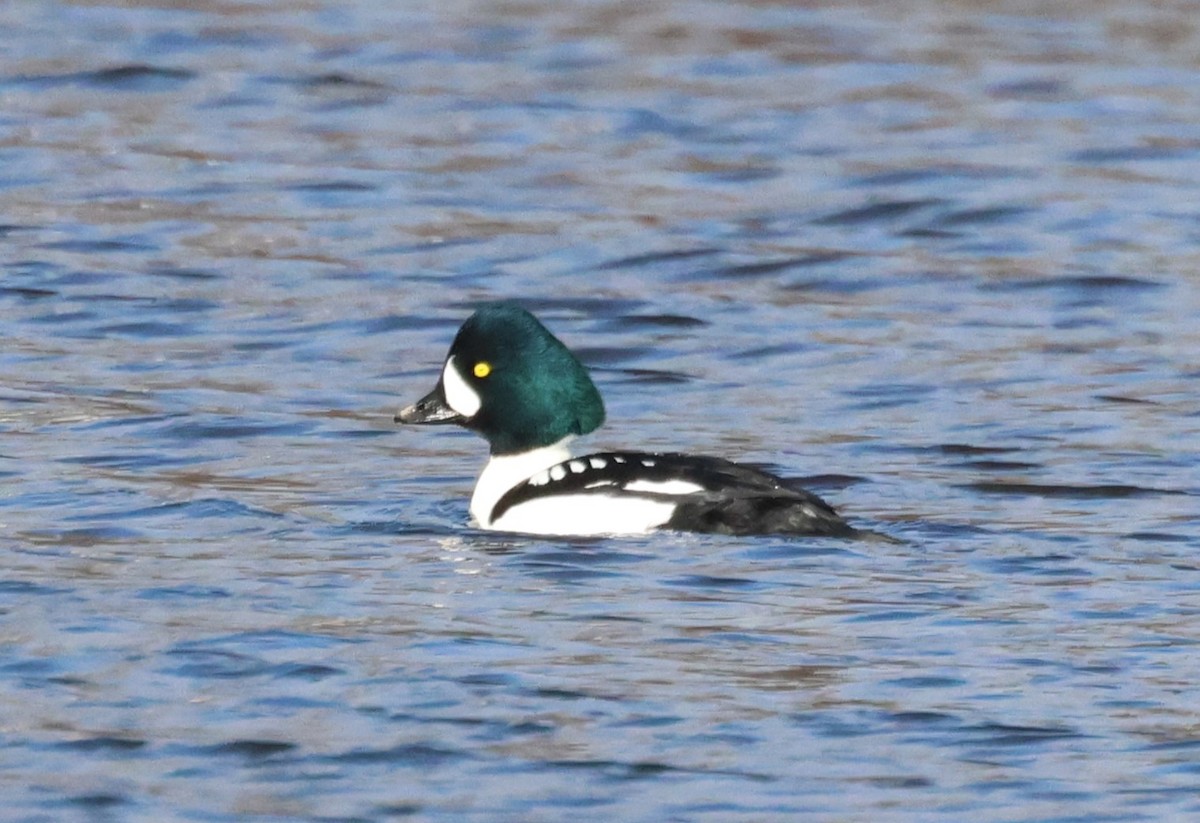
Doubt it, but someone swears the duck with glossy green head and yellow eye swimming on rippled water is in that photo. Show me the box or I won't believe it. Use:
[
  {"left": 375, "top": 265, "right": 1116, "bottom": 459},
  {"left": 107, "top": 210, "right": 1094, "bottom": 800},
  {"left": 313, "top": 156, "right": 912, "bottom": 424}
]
[{"left": 395, "top": 301, "right": 874, "bottom": 537}]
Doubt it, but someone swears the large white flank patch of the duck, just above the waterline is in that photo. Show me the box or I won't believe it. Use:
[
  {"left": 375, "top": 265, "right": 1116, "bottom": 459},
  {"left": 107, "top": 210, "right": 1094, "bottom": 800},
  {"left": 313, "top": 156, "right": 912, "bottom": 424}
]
[{"left": 487, "top": 492, "right": 674, "bottom": 536}]
